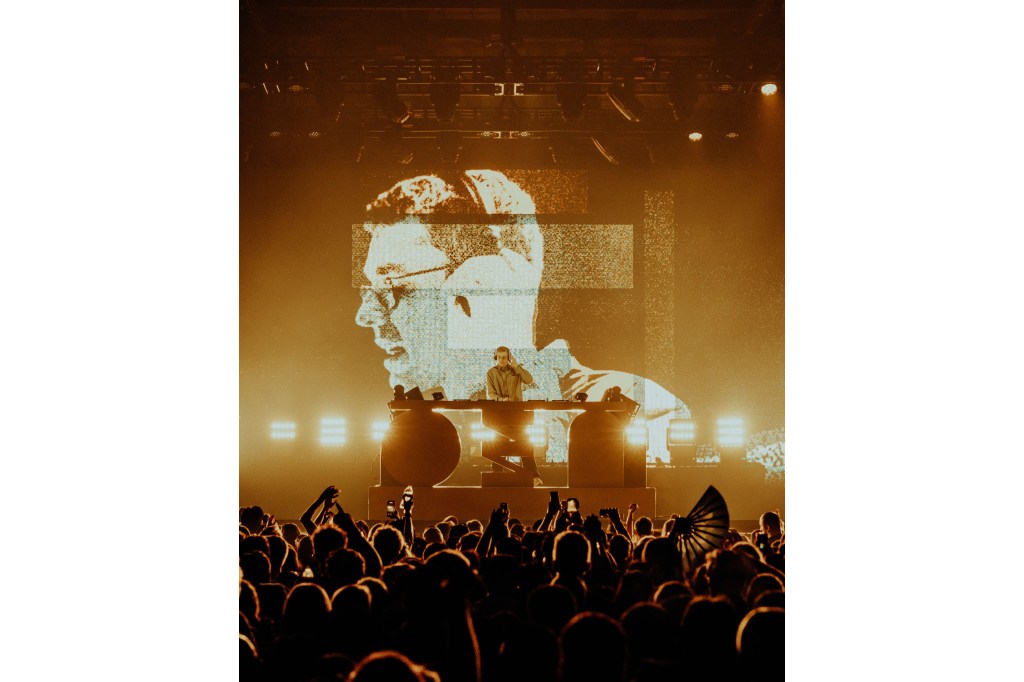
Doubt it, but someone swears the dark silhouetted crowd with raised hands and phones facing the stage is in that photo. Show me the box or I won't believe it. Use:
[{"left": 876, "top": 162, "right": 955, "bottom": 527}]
[{"left": 239, "top": 486, "right": 785, "bottom": 682}]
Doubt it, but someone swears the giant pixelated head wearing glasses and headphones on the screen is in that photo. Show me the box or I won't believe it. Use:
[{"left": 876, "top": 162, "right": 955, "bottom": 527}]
[{"left": 356, "top": 171, "right": 543, "bottom": 394}]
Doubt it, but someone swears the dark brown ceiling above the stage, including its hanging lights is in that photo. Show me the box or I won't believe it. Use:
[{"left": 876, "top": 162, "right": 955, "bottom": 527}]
[{"left": 240, "top": 0, "right": 784, "bottom": 160}]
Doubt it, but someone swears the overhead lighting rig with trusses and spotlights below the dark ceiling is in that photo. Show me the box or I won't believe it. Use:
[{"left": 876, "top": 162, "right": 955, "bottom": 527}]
[{"left": 240, "top": 55, "right": 783, "bottom": 161}]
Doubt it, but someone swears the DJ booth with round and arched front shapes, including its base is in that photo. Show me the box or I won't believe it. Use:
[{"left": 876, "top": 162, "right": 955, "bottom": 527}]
[{"left": 368, "top": 399, "right": 655, "bottom": 520}]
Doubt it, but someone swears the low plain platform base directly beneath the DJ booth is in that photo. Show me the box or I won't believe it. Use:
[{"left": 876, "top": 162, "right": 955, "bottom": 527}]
[{"left": 367, "top": 485, "right": 655, "bottom": 525}]
